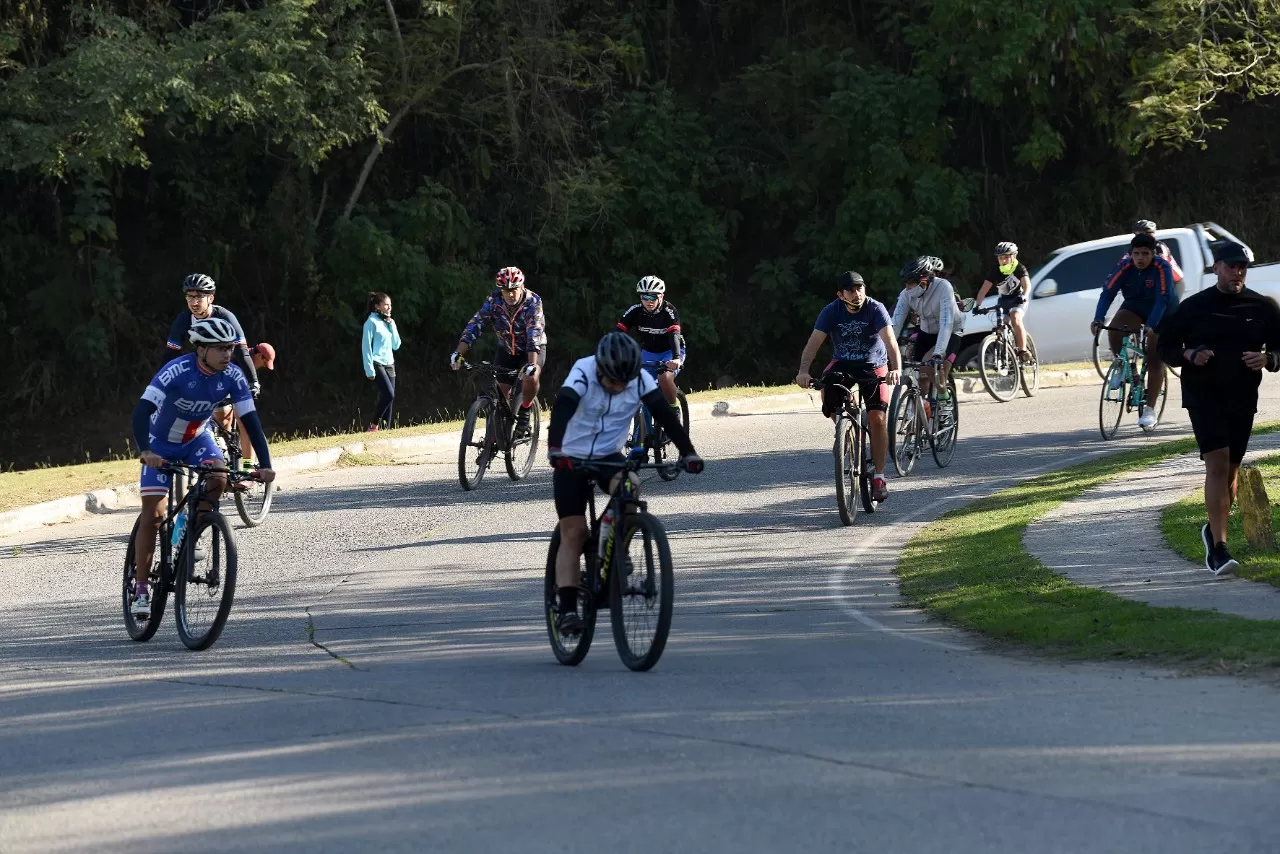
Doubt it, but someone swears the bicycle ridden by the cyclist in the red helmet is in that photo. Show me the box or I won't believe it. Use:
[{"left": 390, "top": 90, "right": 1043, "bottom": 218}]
[{"left": 458, "top": 360, "right": 543, "bottom": 490}]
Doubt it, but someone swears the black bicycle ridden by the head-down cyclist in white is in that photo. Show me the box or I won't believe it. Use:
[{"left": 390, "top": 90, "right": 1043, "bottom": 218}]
[{"left": 544, "top": 457, "right": 676, "bottom": 671}]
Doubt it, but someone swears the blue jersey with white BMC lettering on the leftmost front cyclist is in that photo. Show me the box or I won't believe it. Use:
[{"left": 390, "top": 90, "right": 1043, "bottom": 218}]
[{"left": 142, "top": 353, "right": 255, "bottom": 456}]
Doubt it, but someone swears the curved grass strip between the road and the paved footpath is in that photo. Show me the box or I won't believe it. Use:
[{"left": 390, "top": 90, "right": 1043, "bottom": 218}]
[{"left": 897, "top": 424, "right": 1280, "bottom": 668}]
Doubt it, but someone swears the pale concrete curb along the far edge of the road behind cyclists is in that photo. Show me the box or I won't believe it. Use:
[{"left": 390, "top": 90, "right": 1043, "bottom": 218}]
[{"left": 0, "top": 370, "right": 1100, "bottom": 536}]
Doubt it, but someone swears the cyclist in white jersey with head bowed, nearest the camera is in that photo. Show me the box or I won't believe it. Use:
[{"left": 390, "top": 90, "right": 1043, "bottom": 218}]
[{"left": 547, "top": 332, "right": 703, "bottom": 636}]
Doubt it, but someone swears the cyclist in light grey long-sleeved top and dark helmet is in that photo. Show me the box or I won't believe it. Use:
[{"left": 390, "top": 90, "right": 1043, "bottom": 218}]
[{"left": 893, "top": 255, "right": 963, "bottom": 401}]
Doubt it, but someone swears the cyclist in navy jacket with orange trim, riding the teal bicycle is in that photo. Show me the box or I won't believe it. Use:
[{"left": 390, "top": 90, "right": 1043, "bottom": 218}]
[{"left": 1089, "top": 233, "right": 1178, "bottom": 430}]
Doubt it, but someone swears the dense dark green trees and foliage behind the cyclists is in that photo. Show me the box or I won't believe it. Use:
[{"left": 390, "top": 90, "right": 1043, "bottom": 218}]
[{"left": 0, "top": 0, "right": 1280, "bottom": 468}]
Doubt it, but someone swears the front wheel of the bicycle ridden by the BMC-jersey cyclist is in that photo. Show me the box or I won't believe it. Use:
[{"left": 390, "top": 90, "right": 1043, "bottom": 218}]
[{"left": 173, "top": 511, "right": 236, "bottom": 649}]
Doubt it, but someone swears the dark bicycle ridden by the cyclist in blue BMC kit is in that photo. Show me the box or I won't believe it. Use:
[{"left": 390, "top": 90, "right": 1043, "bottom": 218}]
[{"left": 123, "top": 463, "right": 253, "bottom": 650}]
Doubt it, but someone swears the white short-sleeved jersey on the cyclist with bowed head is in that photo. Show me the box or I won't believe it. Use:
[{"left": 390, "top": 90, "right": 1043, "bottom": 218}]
[{"left": 561, "top": 356, "right": 658, "bottom": 460}]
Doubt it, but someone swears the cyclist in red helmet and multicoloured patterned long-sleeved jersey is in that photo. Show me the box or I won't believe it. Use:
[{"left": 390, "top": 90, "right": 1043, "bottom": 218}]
[{"left": 449, "top": 266, "right": 547, "bottom": 435}]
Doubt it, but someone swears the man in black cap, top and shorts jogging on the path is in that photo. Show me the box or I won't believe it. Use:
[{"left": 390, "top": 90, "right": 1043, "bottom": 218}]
[{"left": 1160, "top": 241, "right": 1280, "bottom": 575}]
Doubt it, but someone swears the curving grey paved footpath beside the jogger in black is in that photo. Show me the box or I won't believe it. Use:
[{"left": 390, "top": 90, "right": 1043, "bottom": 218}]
[{"left": 1023, "top": 434, "right": 1280, "bottom": 620}]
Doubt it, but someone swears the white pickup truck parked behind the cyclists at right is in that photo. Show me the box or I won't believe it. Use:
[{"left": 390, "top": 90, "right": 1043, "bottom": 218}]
[{"left": 956, "top": 223, "right": 1280, "bottom": 367}]
